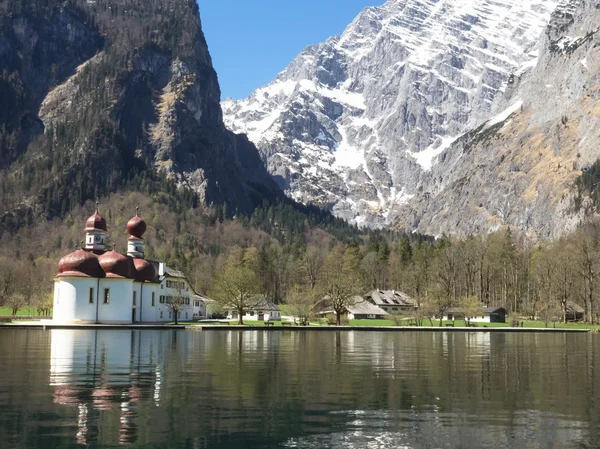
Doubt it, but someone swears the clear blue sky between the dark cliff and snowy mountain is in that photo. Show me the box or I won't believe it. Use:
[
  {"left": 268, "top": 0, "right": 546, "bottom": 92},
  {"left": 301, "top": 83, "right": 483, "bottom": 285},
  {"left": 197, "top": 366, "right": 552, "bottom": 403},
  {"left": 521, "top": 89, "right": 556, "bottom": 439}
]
[{"left": 198, "top": 0, "right": 384, "bottom": 99}]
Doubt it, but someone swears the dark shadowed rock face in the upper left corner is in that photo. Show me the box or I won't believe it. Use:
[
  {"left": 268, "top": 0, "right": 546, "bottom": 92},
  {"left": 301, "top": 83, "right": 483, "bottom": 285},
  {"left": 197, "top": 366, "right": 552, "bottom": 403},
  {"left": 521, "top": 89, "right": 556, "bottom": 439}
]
[{"left": 0, "top": 4, "right": 103, "bottom": 168}]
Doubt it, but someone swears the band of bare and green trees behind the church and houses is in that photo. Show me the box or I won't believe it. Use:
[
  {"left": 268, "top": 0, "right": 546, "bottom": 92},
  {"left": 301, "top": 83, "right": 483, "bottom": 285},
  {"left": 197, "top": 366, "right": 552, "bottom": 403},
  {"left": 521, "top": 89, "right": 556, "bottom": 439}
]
[{"left": 0, "top": 192, "right": 600, "bottom": 323}]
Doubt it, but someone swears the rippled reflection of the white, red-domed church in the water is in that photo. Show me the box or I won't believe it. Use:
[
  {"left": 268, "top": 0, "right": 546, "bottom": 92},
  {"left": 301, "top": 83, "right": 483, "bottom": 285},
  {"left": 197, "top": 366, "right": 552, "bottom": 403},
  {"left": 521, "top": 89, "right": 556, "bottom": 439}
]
[{"left": 50, "top": 329, "right": 175, "bottom": 445}]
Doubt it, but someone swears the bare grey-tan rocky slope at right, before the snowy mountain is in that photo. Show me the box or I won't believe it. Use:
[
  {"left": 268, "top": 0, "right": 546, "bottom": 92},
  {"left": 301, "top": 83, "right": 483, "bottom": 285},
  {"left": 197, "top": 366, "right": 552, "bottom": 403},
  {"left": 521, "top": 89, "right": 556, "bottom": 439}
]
[{"left": 396, "top": 0, "right": 600, "bottom": 237}]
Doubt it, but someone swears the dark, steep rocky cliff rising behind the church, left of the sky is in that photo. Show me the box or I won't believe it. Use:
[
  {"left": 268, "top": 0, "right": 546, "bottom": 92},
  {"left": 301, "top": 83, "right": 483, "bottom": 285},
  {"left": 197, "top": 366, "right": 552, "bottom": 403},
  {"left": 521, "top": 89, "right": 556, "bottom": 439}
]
[{"left": 0, "top": 0, "right": 282, "bottom": 226}]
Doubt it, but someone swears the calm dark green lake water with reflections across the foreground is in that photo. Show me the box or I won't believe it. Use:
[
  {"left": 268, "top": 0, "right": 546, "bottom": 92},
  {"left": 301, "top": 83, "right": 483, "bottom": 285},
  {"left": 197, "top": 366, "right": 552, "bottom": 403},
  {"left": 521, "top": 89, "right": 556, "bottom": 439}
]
[{"left": 0, "top": 329, "right": 600, "bottom": 449}]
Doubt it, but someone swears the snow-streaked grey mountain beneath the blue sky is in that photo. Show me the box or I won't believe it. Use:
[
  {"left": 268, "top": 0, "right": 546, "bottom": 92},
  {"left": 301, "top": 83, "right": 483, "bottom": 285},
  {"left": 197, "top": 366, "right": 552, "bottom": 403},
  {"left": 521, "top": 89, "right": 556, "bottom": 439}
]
[{"left": 222, "top": 0, "right": 559, "bottom": 226}]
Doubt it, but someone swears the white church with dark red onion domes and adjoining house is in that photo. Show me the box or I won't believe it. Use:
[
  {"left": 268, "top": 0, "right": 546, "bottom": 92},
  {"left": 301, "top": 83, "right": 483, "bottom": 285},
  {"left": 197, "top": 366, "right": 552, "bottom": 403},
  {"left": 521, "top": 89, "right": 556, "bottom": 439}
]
[{"left": 53, "top": 206, "right": 206, "bottom": 324}]
